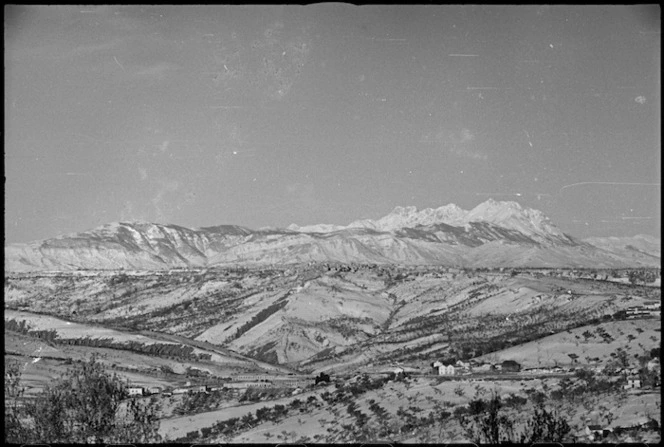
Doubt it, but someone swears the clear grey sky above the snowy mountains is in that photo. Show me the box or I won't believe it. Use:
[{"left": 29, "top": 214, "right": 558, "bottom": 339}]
[{"left": 4, "top": 3, "right": 661, "bottom": 243}]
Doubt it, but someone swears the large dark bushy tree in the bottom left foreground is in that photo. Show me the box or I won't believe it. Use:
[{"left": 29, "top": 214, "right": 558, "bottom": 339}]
[{"left": 5, "top": 357, "right": 161, "bottom": 444}]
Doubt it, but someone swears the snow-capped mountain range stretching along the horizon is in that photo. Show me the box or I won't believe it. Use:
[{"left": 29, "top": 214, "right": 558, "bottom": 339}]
[{"left": 5, "top": 199, "right": 661, "bottom": 272}]
